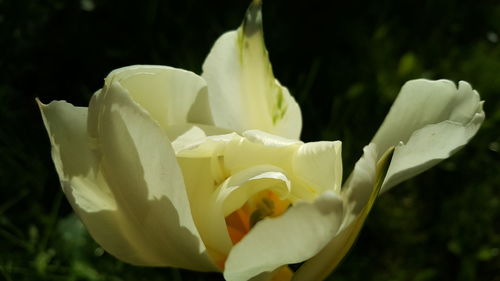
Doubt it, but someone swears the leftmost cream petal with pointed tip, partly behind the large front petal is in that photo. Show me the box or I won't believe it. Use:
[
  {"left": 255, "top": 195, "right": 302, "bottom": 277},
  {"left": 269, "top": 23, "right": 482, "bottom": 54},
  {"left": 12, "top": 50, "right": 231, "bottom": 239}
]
[{"left": 37, "top": 100, "right": 140, "bottom": 264}]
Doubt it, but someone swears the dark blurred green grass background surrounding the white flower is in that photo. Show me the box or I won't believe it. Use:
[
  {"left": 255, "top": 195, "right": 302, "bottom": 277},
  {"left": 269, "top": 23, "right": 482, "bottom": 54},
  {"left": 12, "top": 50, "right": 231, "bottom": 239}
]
[{"left": 0, "top": 0, "right": 500, "bottom": 281}]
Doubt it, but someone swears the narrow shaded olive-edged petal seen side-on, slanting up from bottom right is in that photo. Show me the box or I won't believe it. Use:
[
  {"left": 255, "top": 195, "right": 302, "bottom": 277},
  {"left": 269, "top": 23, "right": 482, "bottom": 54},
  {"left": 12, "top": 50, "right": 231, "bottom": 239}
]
[{"left": 292, "top": 144, "right": 394, "bottom": 280}]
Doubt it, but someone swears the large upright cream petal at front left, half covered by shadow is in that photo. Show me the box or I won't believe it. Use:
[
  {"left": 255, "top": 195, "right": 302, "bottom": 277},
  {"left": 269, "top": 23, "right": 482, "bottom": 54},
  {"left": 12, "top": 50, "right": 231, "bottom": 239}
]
[{"left": 84, "top": 82, "right": 216, "bottom": 270}]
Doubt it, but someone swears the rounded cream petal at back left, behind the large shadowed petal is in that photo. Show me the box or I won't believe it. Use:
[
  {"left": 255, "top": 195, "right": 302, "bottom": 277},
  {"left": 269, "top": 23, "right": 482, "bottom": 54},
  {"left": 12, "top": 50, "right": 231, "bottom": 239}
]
[{"left": 105, "top": 65, "right": 212, "bottom": 128}]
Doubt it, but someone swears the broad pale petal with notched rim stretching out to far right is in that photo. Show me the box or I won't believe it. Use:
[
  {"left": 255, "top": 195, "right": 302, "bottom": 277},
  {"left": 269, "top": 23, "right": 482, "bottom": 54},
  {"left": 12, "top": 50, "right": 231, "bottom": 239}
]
[{"left": 372, "top": 79, "right": 484, "bottom": 191}]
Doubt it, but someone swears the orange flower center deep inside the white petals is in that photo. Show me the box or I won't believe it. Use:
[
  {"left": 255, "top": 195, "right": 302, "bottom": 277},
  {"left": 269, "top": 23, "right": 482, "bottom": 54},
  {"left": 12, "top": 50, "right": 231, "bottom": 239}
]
[{"left": 226, "top": 190, "right": 290, "bottom": 244}]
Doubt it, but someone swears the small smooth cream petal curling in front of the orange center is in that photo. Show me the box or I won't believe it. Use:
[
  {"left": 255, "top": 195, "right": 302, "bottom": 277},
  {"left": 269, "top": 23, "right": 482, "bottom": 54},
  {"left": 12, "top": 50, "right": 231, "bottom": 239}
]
[{"left": 224, "top": 192, "right": 343, "bottom": 281}]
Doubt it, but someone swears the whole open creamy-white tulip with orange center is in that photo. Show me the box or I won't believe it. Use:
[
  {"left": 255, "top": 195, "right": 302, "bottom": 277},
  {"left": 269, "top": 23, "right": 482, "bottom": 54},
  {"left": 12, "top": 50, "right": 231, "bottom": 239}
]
[{"left": 39, "top": 1, "right": 484, "bottom": 280}]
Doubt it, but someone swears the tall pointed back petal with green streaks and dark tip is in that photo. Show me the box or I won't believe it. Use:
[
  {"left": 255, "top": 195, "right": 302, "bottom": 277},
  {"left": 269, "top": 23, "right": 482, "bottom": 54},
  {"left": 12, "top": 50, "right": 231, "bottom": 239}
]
[{"left": 202, "top": 1, "right": 302, "bottom": 139}]
